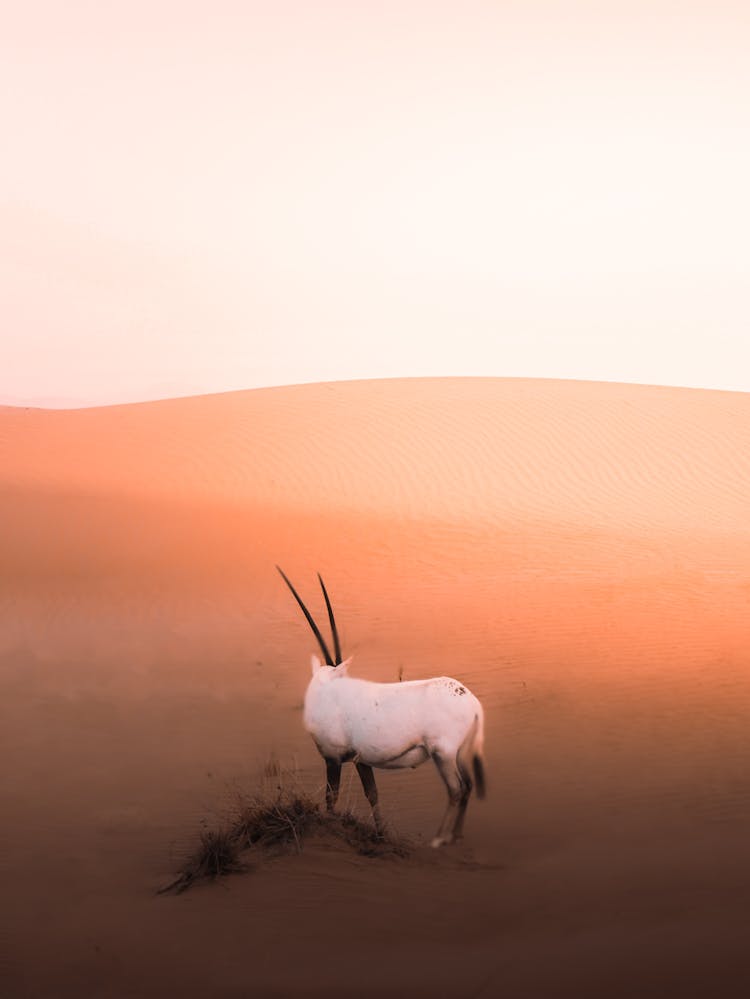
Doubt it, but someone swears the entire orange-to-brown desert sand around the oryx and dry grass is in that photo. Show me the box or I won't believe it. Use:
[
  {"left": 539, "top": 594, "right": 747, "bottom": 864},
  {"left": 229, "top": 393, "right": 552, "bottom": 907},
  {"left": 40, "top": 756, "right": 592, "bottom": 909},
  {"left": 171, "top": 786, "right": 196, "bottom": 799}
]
[{"left": 0, "top": 378, "right": 750, "bottom": 999}]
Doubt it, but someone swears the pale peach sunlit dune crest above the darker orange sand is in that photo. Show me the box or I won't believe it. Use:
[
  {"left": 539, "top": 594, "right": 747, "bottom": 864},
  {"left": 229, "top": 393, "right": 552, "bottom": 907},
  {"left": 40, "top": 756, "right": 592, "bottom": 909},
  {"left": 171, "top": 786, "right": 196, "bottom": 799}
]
[{"left": 0, "top": 378, "right": 750, "bottom": 532}]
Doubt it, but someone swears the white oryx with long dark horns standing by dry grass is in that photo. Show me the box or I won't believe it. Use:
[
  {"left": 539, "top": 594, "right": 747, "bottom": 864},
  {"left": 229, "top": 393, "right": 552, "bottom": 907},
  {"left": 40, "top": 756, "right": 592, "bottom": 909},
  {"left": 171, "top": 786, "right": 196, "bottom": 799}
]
[{"left": 276, "top": 566, "right": 485, "bottom": 846}]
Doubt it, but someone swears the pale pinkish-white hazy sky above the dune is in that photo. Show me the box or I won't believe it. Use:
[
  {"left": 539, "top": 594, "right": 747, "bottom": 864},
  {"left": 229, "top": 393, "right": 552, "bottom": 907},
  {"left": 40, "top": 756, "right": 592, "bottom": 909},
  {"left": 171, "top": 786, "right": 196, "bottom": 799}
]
[{"left": 0, "top": 0, "right": 750, "bottom": 405}]
